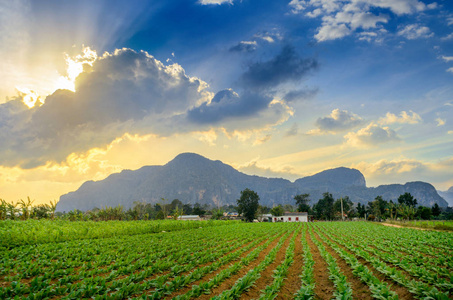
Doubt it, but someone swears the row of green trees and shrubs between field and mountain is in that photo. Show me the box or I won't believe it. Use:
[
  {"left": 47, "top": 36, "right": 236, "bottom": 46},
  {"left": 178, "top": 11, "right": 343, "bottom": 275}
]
[{"left": 0, "top": 189, "right": 453, "bottom": 221}]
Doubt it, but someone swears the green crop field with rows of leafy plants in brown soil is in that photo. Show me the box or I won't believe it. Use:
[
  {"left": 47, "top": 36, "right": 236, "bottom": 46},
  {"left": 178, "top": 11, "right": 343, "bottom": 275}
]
[{"left": 0, "top": 221, "right": 453, "bottom": 299}]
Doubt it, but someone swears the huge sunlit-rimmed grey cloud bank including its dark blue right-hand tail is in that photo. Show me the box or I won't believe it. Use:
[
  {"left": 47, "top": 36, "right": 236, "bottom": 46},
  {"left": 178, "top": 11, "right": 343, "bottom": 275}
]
[{"left": 0, "top": 49, "right": 302, "bottom": 168}]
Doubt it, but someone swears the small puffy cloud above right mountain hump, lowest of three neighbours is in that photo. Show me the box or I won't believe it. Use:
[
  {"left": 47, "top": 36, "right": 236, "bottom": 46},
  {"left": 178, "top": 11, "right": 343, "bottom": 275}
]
[{"left": 345, "top": 123, "right": 400, "bottom": 147}]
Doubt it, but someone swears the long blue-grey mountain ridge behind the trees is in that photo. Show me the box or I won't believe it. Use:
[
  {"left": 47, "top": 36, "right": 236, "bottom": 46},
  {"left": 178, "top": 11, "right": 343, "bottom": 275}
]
[{"left": 57, "top": 153, "right": 447, "bottom": 212}]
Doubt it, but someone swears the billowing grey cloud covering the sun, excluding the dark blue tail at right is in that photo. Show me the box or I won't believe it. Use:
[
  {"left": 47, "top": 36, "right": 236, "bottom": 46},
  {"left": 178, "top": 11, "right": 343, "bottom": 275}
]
[{"left": 0, "top": 49, "right": 207, "bottom": 168}]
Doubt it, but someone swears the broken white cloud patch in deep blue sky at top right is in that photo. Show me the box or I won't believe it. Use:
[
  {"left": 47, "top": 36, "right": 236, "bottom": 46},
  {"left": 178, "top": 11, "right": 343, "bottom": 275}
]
[{"left": 288, "top": 0, "right": 437, "bottom": 42}]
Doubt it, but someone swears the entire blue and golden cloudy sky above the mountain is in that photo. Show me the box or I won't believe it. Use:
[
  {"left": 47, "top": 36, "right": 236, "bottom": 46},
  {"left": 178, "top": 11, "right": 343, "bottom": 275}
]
[{"left": 0, "top": 0, "right": 453, "bottom": 204}]
